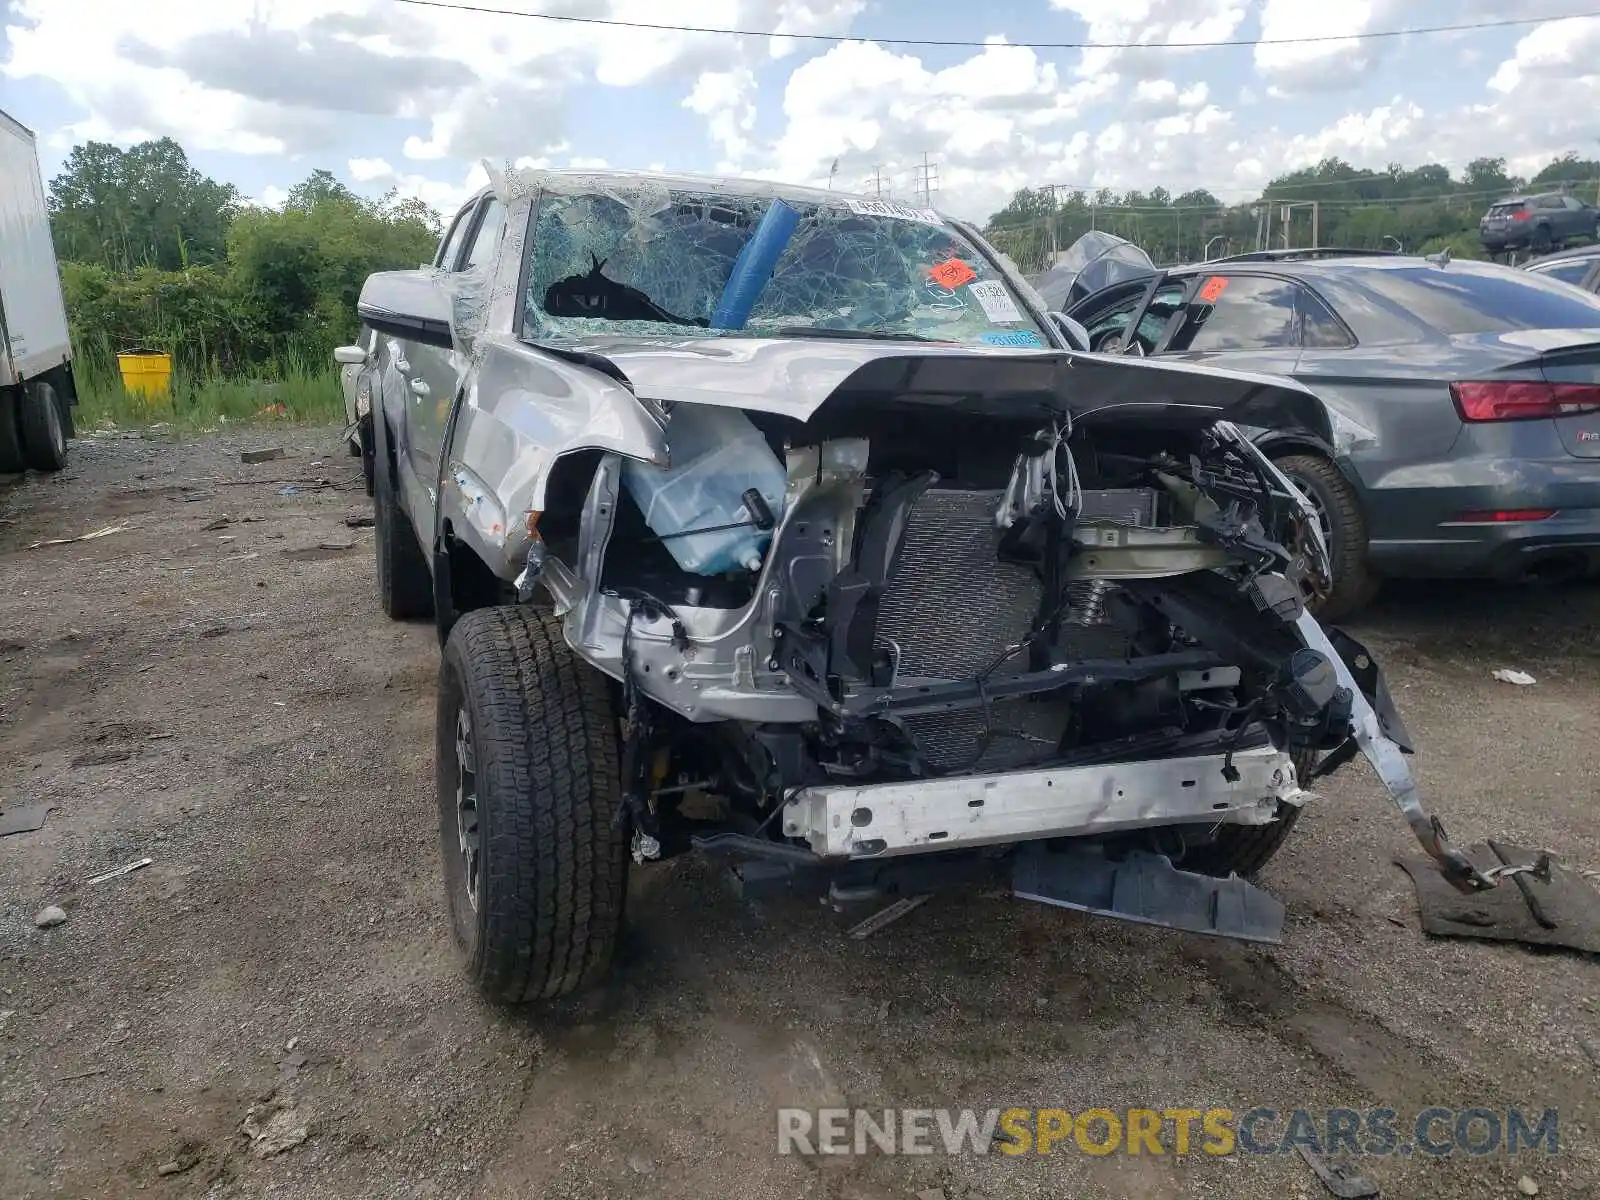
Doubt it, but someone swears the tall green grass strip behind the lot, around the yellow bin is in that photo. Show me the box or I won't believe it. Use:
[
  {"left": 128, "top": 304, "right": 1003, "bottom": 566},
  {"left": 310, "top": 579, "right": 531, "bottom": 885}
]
[{"left": 74, "top": 331, "right": 344, "bottom": 432}]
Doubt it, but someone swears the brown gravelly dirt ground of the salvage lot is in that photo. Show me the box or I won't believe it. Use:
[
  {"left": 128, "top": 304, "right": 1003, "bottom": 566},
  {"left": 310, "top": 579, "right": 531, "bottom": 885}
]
[{"left": 9, "top": 430, "right": 1600, "bottom": 1200}]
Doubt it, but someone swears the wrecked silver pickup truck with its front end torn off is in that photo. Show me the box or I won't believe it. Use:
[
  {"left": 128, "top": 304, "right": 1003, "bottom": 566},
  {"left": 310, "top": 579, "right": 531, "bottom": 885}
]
[{"left": 341, "top": 173, "right": 1494, "bottom": 1000}]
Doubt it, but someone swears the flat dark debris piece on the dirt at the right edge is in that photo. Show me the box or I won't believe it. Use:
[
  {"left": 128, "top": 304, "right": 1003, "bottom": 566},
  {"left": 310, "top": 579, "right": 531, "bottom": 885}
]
[{"left": 1395, "top": 840, "right": 1600, "bottom": 954}]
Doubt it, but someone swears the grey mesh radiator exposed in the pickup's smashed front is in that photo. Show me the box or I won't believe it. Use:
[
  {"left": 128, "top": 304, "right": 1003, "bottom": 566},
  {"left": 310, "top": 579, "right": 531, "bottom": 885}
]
[{"left": 878, "top": 488, "right": 1146, "bottom": 771}]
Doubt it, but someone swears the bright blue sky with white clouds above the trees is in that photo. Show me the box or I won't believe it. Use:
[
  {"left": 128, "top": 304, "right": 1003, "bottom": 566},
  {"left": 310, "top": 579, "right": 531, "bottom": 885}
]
[{"left": 0, "top": 0, "right": 1600, "bottom": 219}]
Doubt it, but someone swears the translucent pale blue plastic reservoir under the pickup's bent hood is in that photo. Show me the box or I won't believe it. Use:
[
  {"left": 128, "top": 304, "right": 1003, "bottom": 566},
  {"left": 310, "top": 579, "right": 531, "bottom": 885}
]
[{"left": 622, "top": 405, "right": 789, "bottom": 574}]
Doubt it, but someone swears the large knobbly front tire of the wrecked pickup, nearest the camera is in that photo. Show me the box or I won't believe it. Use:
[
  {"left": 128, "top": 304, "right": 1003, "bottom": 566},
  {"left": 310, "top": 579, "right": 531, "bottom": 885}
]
[{"left": 435, "top": 606, "right": 627, "bottom": 1003}]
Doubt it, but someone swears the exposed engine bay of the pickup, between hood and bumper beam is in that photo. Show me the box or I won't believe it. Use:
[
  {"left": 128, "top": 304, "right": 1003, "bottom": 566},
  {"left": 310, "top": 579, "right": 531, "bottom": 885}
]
[{"left": 537, "top": 397, "right": 1349, "bottom": 876}]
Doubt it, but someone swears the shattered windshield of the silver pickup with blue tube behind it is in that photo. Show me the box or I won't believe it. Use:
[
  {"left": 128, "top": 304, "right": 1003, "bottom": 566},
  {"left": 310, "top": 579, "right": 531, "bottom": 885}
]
[{"left": 523, "top": 186, "right": 1048, "bottom": 347}]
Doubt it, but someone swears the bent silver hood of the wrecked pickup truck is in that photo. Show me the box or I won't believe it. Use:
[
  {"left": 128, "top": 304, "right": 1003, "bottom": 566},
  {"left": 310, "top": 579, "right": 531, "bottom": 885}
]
[{"left": 541, "top": 338, "right": 1333, "bottom": 443}]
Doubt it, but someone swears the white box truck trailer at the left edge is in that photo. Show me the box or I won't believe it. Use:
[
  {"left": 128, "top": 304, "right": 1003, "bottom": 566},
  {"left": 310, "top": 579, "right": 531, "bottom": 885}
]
[{"left": 0, "top": 112, "right": 78, "bottom": 474}]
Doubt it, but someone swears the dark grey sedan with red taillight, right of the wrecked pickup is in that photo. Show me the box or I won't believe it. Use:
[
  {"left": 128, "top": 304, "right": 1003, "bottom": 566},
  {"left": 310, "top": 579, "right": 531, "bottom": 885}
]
[{"left": 1058, "top": 241, "right": 1600, "bottom": 619}]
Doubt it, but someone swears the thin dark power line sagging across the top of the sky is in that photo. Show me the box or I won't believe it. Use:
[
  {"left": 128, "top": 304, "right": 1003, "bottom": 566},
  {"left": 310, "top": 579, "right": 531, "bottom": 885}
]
[{"left": 380, "top": 0, "right": 1600, "bottom": 50}]
